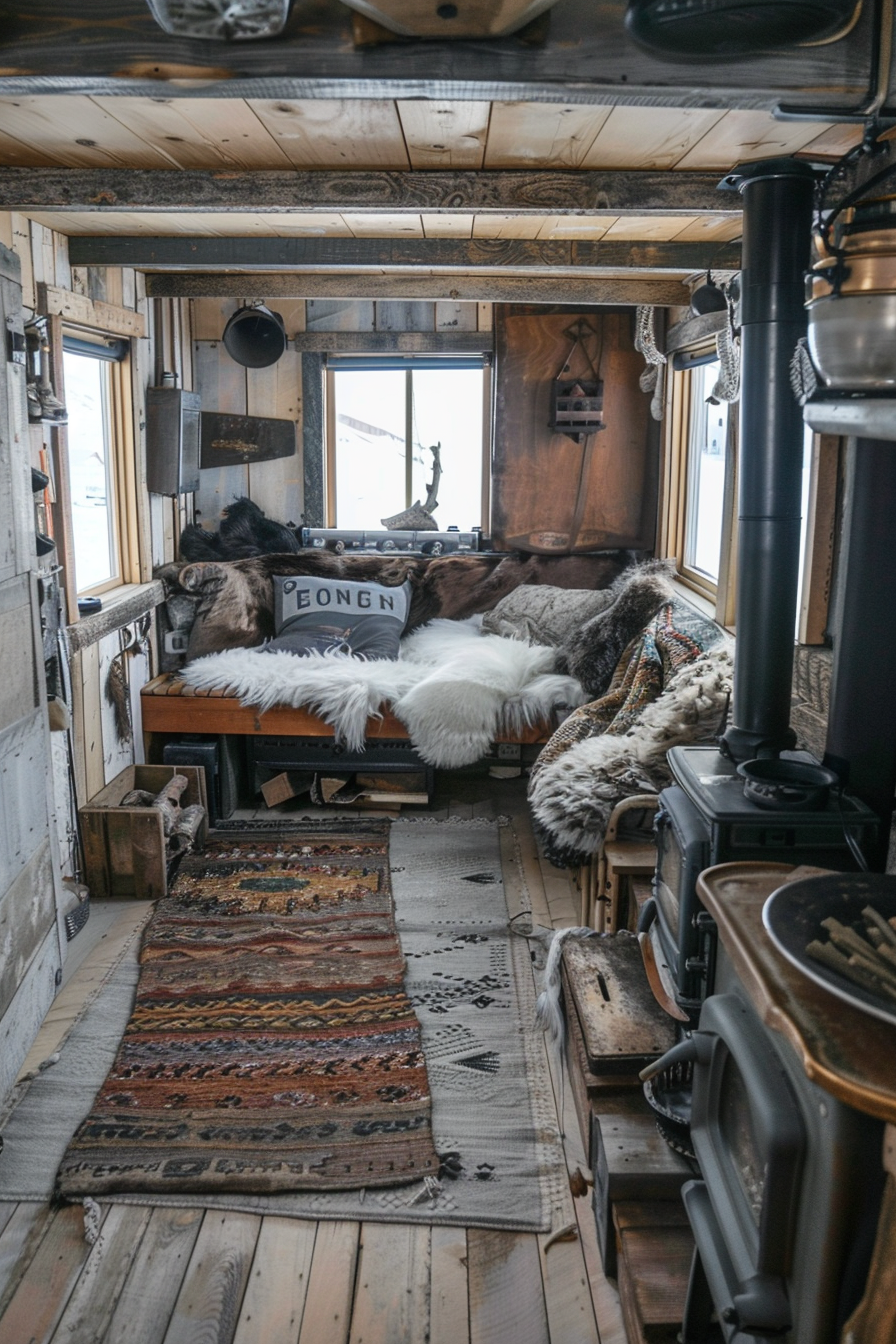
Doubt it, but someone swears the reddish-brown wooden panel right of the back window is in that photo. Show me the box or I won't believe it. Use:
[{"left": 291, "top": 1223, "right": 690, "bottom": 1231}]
[{"left": 492, "top": 305, "right": 660, "bottom": 555}]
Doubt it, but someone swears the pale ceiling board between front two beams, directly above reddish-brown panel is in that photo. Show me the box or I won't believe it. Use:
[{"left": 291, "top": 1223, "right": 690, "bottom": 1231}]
[{"left": 485, "top": 102, "right": 611, "bottom": 168}]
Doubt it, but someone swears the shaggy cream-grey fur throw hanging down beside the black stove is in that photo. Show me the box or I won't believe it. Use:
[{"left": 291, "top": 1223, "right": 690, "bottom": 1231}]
[{"left": 529, "top": 644, "right": 733, "bottom": 866}]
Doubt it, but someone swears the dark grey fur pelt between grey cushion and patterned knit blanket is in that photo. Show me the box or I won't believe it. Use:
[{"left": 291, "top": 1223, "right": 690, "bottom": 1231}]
[{"left": 563, "top": 560, "right": 673, "bottom": 700}]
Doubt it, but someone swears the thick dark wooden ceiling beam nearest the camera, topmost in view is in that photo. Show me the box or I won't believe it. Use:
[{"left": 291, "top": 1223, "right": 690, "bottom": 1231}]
[{"left": 0, "top": 0, "right": 876, "bottom": 108}]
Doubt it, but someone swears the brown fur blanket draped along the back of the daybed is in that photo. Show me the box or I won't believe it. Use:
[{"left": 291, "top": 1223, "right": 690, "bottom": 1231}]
[{"left": 159, "top": 550, "right": 637, "bottom": 661}]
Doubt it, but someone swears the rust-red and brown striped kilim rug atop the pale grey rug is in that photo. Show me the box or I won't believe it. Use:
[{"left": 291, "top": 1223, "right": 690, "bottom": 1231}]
[{"left": 58, "top": 821, "right": 439, "bottom": 1196}]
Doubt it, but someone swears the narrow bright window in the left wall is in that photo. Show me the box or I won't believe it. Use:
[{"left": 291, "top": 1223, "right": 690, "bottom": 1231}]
[{"left": 63, "top": 335, "right": 138, "bottom": 594}]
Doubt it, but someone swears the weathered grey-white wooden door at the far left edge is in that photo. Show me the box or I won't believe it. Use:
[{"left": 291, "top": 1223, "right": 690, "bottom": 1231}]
[{"left": 0, "top": 245, "right": 64, "bottom": 1099}]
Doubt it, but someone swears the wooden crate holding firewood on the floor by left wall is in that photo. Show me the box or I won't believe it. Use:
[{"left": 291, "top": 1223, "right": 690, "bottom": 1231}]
[{"left": 79, "top": 765, "right": 208, "bottom": 900}]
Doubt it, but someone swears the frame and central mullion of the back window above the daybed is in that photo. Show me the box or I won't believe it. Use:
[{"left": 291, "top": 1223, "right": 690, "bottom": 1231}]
[{"left": 322, "top": 351, "right": 493, "bottom": 534}]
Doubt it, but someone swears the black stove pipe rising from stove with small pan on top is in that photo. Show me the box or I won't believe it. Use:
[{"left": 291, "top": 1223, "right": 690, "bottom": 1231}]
[{"left": 720, "top": 159, "right": 814, "bottom": 761}]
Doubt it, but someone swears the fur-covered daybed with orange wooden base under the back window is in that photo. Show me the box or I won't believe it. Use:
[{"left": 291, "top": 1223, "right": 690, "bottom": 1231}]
[{"left": 142, "top": 552, "right": 732, "bottom": 866}]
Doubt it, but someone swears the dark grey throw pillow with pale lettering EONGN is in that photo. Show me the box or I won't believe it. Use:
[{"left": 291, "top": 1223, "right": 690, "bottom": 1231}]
[{"left": 265, "top": 574, "right": 411, "bottom": 659}]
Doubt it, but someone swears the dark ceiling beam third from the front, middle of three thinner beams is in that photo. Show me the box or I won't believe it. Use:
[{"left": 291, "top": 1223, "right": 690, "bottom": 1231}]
[{"left": 69, "top": 234, "right": 740, "bottom": 276}]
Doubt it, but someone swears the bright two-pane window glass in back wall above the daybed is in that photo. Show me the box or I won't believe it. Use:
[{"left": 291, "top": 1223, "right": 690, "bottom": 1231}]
[{"left": 326, "top": 356, "right": 488, "bottom": 532}]
